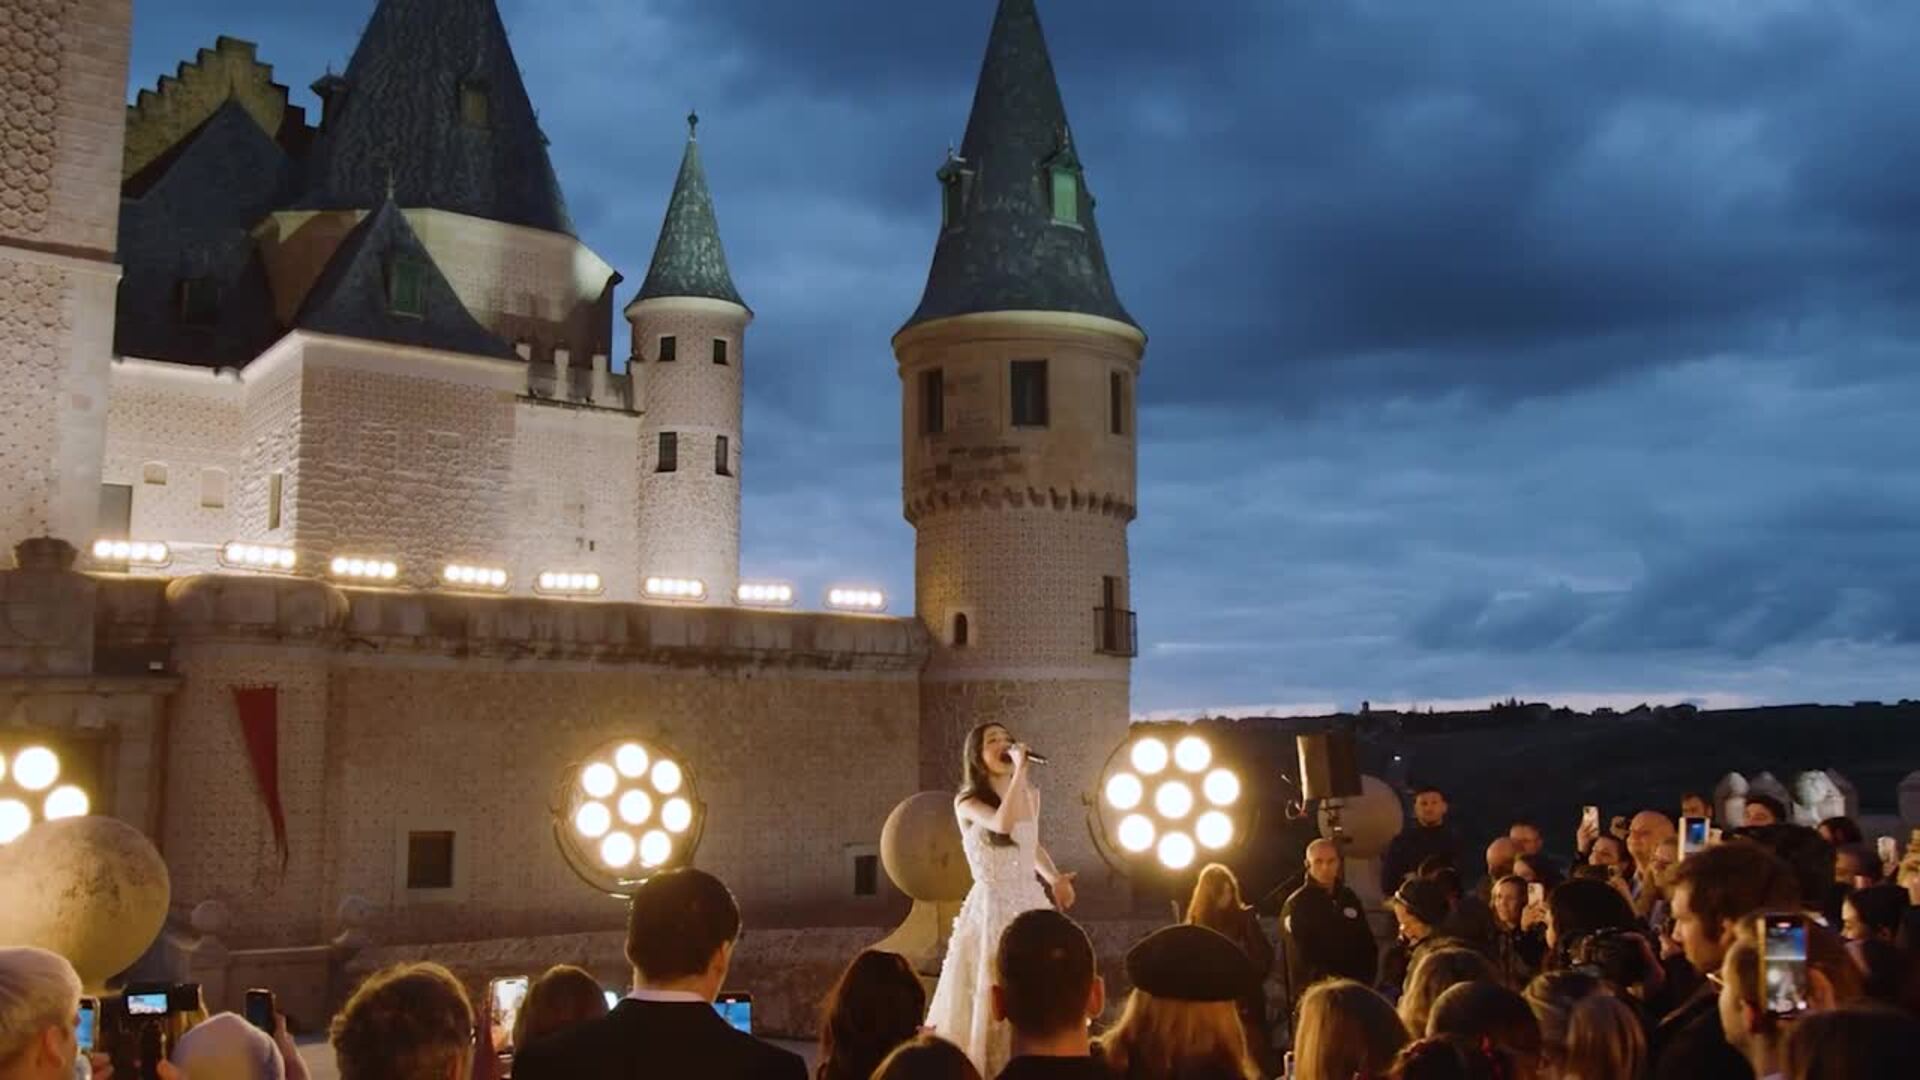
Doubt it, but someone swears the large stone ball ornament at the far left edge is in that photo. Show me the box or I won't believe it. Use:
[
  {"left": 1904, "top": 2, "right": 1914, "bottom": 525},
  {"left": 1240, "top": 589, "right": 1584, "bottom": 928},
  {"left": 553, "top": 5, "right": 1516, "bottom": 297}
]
[{"left": 0, "top": 817, "right": 173, "bottom": 992}]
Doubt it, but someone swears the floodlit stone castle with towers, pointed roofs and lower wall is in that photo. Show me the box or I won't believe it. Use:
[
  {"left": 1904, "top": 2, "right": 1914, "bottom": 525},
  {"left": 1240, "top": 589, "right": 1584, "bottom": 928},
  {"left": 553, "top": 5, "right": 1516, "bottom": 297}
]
[{"left": 0, "top": 0, "right": 1146, "bottom": 1022}]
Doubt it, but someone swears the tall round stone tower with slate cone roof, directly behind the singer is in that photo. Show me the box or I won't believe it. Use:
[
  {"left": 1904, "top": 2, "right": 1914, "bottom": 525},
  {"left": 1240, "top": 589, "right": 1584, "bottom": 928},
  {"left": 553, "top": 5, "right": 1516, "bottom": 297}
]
[{"left": 893, "top": 0, "right": 1146, "bottom": 882}]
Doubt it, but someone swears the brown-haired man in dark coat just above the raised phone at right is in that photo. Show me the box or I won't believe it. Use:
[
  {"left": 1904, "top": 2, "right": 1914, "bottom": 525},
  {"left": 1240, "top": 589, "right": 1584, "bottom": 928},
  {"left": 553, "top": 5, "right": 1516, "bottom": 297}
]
[{"left": 1651, "top": 840, "right": 1801, "bottom": 1080}]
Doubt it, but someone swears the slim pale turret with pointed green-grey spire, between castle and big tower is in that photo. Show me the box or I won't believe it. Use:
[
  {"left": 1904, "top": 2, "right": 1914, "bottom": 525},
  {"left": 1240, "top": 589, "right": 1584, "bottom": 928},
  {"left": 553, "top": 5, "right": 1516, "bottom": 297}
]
[{"left": 626, "top": 115, "right": 753, "bottom": 603}]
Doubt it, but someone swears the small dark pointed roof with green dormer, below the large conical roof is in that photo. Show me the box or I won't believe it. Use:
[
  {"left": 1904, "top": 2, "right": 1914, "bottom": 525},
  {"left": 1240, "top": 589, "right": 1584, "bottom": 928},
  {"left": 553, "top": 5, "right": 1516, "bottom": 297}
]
[{"left": 294, "top": 196, "right": 518, "bottom": 359}]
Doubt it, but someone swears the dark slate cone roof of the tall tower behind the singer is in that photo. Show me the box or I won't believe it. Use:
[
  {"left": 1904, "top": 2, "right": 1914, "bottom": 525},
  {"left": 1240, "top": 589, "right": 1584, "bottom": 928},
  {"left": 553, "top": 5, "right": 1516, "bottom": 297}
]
[{"left": 906, "top": 0, "right": 1137, "bottom": 327}]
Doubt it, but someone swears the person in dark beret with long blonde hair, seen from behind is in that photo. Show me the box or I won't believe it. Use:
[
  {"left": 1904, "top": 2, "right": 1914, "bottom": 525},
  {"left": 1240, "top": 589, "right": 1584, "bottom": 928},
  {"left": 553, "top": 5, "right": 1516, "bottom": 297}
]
[{"left": 1100, "top": 924, "right": 1260, "bottom": 1080}]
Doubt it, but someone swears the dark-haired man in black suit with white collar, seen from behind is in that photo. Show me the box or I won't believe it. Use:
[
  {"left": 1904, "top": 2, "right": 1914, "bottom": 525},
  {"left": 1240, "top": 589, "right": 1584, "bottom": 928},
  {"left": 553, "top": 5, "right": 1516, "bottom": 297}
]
[{"left": 513, "top": 869, "right": 806, "bottom": 1080}]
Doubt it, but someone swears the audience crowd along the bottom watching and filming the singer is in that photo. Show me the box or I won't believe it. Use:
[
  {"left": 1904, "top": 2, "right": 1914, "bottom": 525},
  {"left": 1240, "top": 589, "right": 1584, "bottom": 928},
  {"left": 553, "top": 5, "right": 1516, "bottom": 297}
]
[{"left": 11, "top": 788, "right": 1920, "bottom": 1080}]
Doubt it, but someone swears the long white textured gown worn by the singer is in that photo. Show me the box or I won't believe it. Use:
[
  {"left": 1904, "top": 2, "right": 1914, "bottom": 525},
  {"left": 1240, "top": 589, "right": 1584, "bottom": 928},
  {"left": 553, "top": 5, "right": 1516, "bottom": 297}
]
[{"left": 927, "top": 821, "right": 1052, "bottom": 1076}]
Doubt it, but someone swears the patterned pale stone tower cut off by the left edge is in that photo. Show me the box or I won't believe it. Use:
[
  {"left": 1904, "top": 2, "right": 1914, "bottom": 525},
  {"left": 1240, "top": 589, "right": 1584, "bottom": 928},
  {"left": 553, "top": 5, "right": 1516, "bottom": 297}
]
[{"left": 0, "top": 0, "right": 132, "bottom": 553}]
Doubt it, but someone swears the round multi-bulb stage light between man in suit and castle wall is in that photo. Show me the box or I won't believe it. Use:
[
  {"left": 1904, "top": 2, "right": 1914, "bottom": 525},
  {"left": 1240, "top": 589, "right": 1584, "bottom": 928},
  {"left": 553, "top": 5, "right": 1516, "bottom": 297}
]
[{"left": 551, "top": 736, "right": 705, "bottom": 897}]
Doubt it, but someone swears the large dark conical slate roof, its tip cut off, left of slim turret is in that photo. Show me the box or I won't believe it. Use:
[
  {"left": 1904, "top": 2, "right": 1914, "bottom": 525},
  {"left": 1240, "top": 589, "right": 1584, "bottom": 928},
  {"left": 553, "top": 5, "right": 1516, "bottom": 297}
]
[{"left": 301, "top": 0, "right": 574, "bottom": 234}]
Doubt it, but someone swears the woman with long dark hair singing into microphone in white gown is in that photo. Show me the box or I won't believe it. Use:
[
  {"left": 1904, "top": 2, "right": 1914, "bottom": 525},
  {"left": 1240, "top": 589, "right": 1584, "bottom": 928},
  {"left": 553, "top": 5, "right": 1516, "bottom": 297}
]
[{"left": 927, "top": 724, "right": 1073, "bottom": 1076}]
